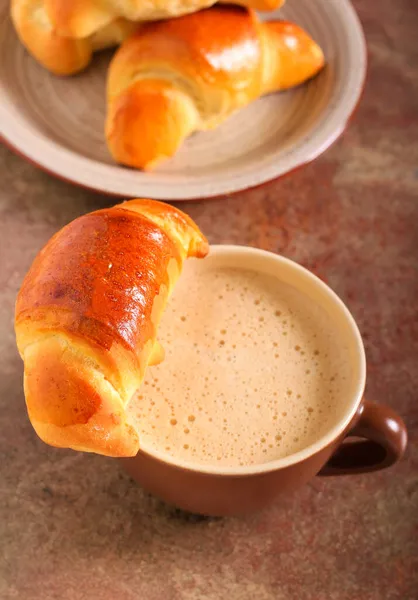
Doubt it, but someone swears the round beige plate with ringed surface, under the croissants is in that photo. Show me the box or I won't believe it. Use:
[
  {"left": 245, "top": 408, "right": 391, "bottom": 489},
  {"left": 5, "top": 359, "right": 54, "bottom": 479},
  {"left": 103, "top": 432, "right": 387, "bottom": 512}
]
[{"left": 0, "top": 0, "right": 366, "bottom": 200}]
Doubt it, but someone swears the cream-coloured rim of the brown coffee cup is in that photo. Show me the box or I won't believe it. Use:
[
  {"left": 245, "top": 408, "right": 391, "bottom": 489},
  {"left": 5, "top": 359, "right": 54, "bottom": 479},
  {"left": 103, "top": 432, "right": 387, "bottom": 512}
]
[{"left": 139, "top": 244, "right": 366, "bottom": 476}]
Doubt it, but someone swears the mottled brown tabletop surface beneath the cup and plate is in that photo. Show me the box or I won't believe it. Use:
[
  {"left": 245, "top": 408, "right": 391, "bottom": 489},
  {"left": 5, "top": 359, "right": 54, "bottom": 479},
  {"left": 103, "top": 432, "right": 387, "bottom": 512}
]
[{"left": 0, "top": 0, "right": 418, "bottom": 600}]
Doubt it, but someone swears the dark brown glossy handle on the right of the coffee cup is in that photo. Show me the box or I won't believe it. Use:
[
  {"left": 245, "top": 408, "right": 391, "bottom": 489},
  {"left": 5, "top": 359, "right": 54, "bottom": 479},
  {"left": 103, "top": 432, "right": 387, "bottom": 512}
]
[{"left": 318, "top": 400, "right": 408, "bottom": 475}]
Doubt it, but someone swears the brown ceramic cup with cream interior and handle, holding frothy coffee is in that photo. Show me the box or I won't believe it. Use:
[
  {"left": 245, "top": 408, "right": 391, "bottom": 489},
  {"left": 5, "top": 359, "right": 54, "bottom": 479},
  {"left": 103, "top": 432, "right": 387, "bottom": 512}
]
[{"left": 121, "top": 246, "right": 407, "bottom": 516}]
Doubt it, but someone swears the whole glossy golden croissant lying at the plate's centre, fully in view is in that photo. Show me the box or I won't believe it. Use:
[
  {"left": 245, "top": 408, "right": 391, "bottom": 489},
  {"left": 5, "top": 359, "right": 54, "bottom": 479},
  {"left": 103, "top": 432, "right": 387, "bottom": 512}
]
[{"left": 105, "top": 5, "right": 324, "bottom": 169}]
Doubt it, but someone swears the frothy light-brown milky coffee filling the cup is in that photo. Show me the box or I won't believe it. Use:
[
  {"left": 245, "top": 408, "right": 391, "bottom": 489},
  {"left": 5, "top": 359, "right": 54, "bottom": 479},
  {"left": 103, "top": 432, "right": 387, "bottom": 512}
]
[{"left": 130, "top": 261, "right": 350, "bottom": 466}]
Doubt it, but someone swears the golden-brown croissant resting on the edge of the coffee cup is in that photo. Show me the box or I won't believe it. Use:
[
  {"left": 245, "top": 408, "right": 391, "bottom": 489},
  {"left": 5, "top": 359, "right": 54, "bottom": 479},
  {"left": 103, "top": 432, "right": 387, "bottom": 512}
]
[{"left": 15, "top": 200, "right": 208, "bottom": 456}]
